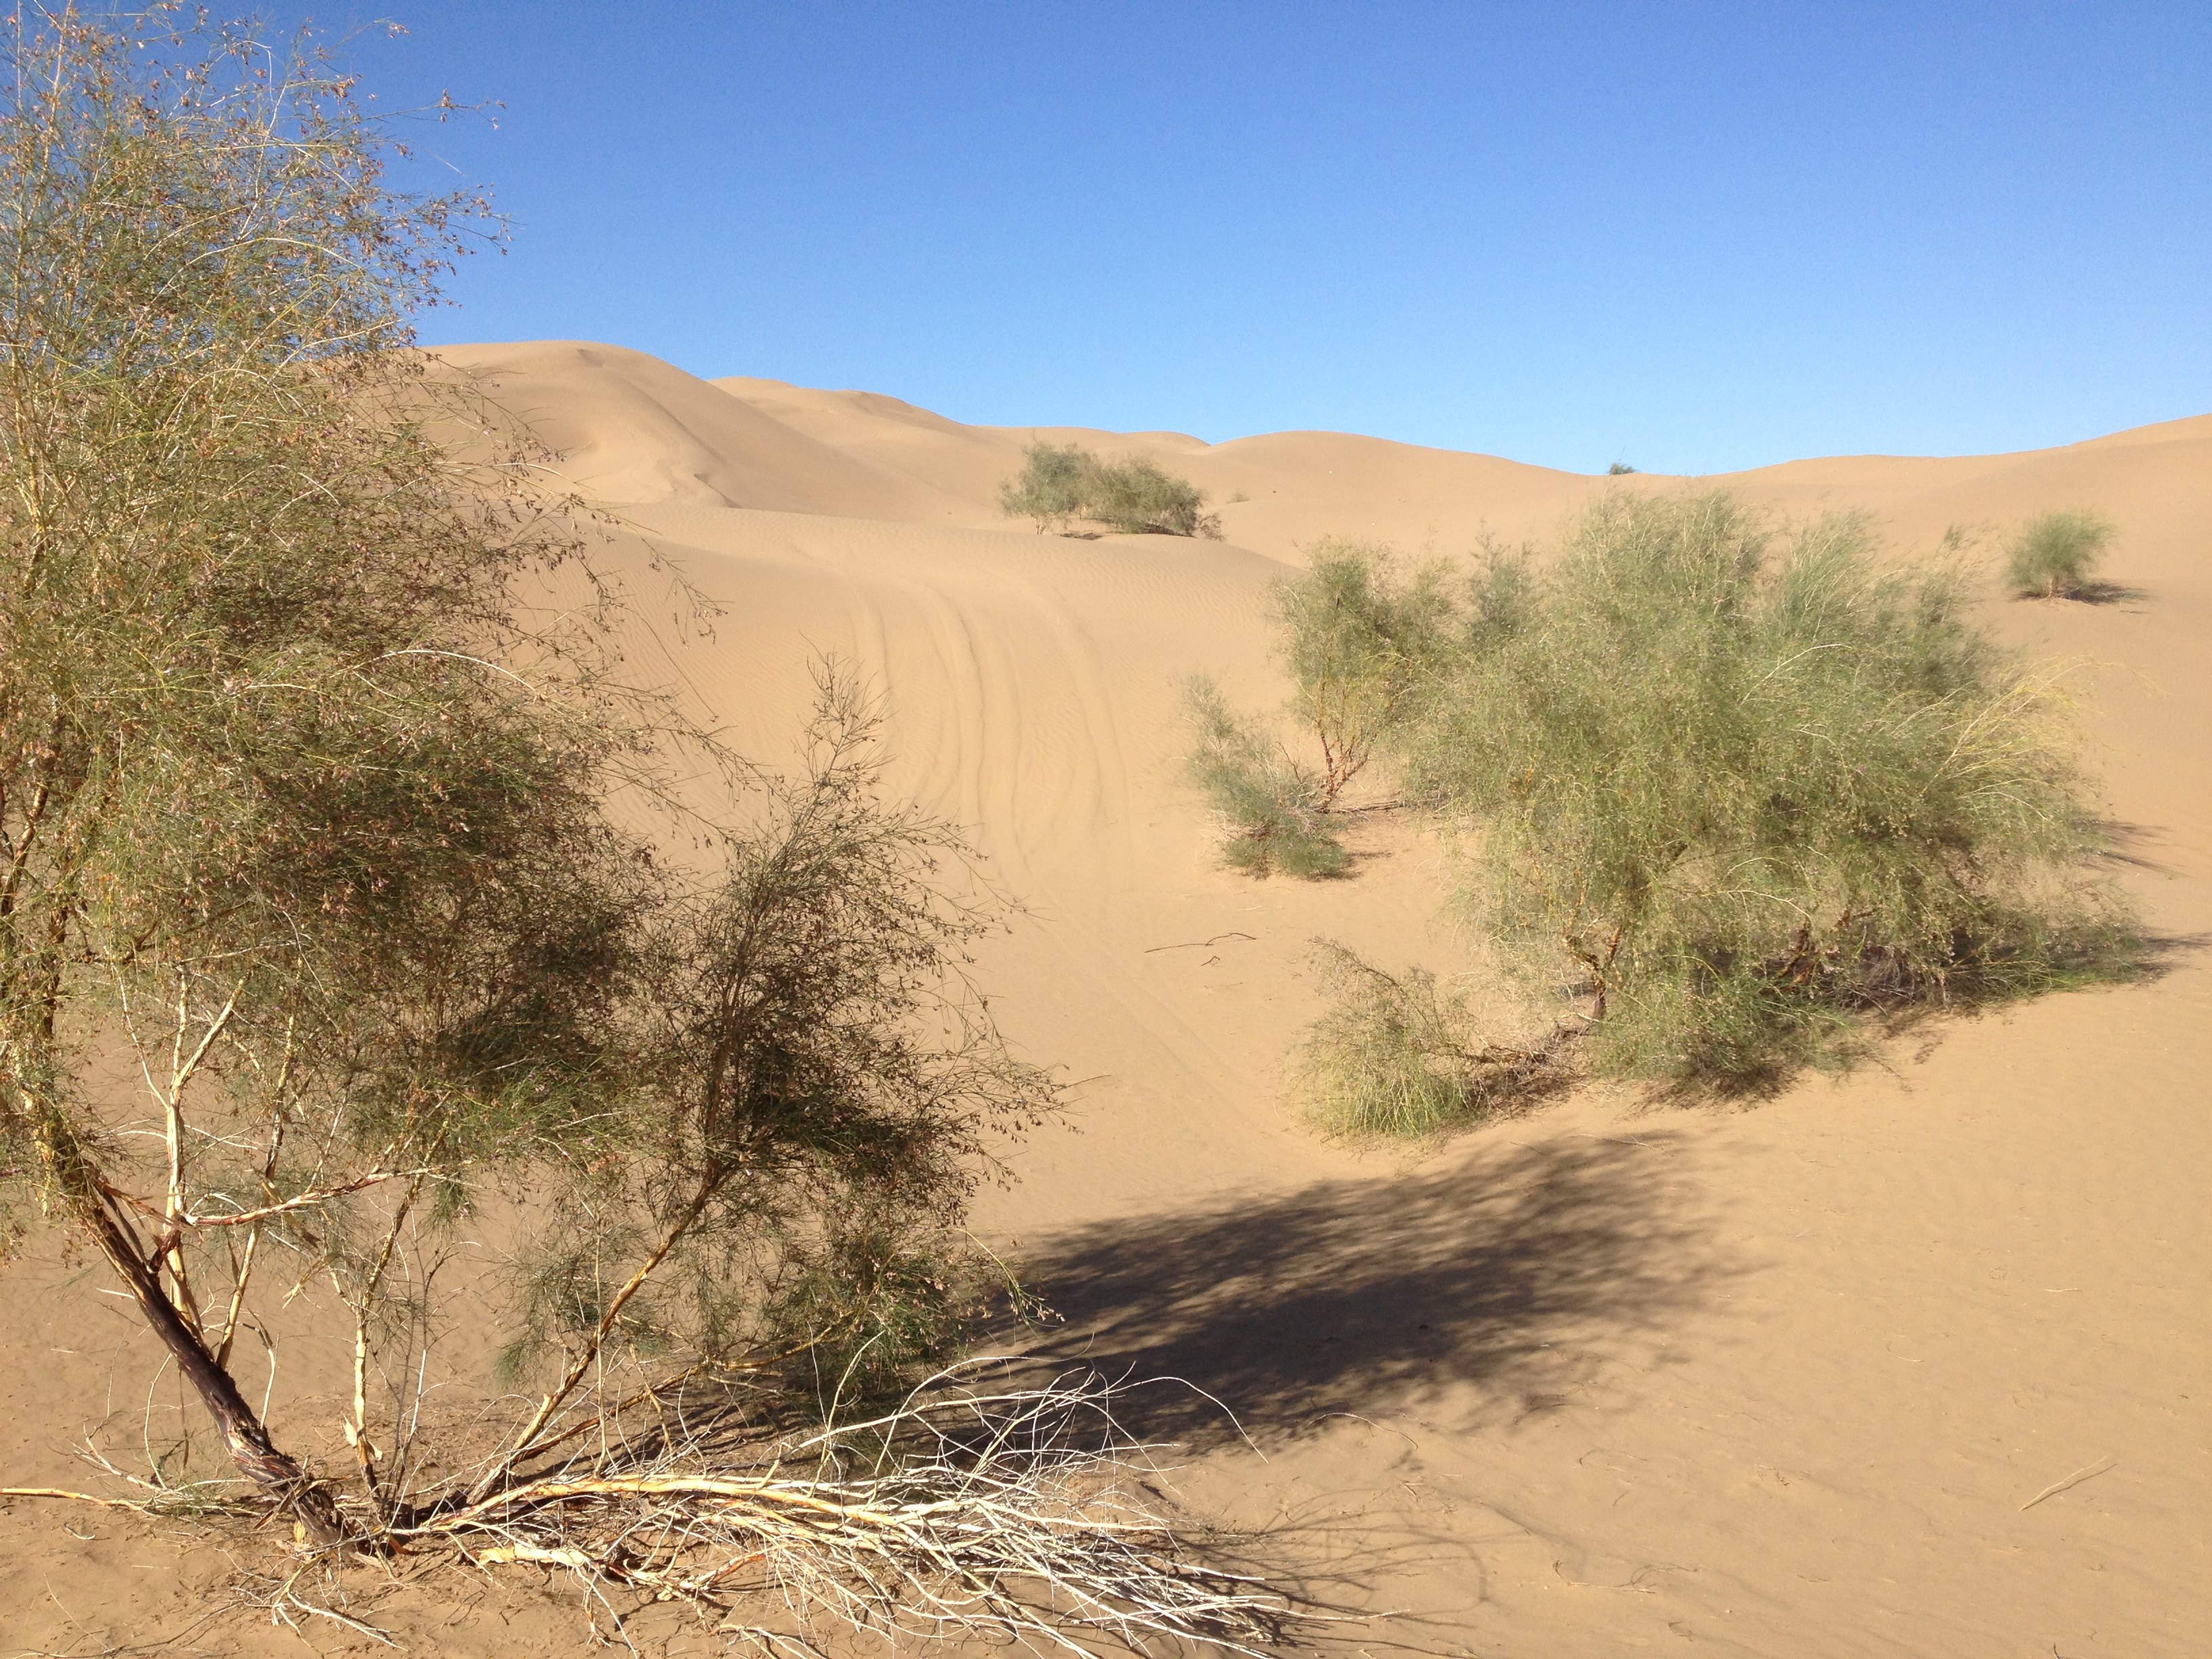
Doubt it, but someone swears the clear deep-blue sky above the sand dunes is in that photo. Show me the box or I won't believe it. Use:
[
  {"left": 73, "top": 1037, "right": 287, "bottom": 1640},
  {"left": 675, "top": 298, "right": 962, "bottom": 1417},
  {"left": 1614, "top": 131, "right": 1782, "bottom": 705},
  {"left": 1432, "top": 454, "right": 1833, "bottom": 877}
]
[{"left": 336, "top": 0, "right": 2212, "bottom": 473}]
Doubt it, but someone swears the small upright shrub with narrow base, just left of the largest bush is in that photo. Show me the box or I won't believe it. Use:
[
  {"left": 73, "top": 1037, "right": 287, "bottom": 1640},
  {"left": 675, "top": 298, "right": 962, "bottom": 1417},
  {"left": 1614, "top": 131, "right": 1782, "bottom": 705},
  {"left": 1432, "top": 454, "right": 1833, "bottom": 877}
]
[{"left": 1270, "top": 537, "right": 1456, "bottom": 810}]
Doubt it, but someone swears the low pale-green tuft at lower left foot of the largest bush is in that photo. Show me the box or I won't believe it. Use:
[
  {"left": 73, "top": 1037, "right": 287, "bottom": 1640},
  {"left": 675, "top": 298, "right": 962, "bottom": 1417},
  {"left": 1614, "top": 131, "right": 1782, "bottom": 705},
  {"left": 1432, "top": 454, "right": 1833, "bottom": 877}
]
[{"left": 1292, "top": 938, "right": 1566, "bottom": 1137}]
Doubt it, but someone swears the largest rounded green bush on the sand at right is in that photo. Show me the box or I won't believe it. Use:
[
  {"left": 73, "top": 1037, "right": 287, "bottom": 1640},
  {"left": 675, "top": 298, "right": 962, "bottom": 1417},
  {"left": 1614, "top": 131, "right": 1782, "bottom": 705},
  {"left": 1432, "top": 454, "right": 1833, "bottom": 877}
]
[{"left": 1407, "top": 493, "right": 2126, "bottom": 1084}]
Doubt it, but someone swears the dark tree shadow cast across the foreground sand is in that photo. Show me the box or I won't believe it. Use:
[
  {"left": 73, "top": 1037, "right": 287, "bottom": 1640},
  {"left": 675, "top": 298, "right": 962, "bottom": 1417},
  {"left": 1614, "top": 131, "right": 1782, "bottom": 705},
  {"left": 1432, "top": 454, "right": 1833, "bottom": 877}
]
[{"left": 1026, "top": 1132, "right": 1734, "bottom": 1444}]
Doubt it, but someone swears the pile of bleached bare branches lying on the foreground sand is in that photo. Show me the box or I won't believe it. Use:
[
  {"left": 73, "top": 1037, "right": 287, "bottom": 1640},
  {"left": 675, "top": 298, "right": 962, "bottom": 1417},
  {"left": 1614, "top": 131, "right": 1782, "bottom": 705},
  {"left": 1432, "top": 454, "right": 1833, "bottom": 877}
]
[{"left": 392, "top": 1374, "right": 1330, "bottom": 1659}]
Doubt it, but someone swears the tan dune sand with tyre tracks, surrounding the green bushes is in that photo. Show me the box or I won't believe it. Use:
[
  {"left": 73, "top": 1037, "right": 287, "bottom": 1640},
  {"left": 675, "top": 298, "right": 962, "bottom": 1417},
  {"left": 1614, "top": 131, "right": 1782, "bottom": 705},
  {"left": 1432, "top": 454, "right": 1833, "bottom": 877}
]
[{"left": 0, "top": 345, "right": 2212, "bottom": 1659}]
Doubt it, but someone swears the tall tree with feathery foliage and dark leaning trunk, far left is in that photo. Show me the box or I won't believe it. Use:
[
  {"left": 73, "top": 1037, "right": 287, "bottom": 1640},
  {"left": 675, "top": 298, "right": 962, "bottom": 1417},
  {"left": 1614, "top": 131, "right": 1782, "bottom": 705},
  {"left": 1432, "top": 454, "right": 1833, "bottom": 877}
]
[{"left": 0, "top": 3, "right": 615, "bottom": 1535}]
